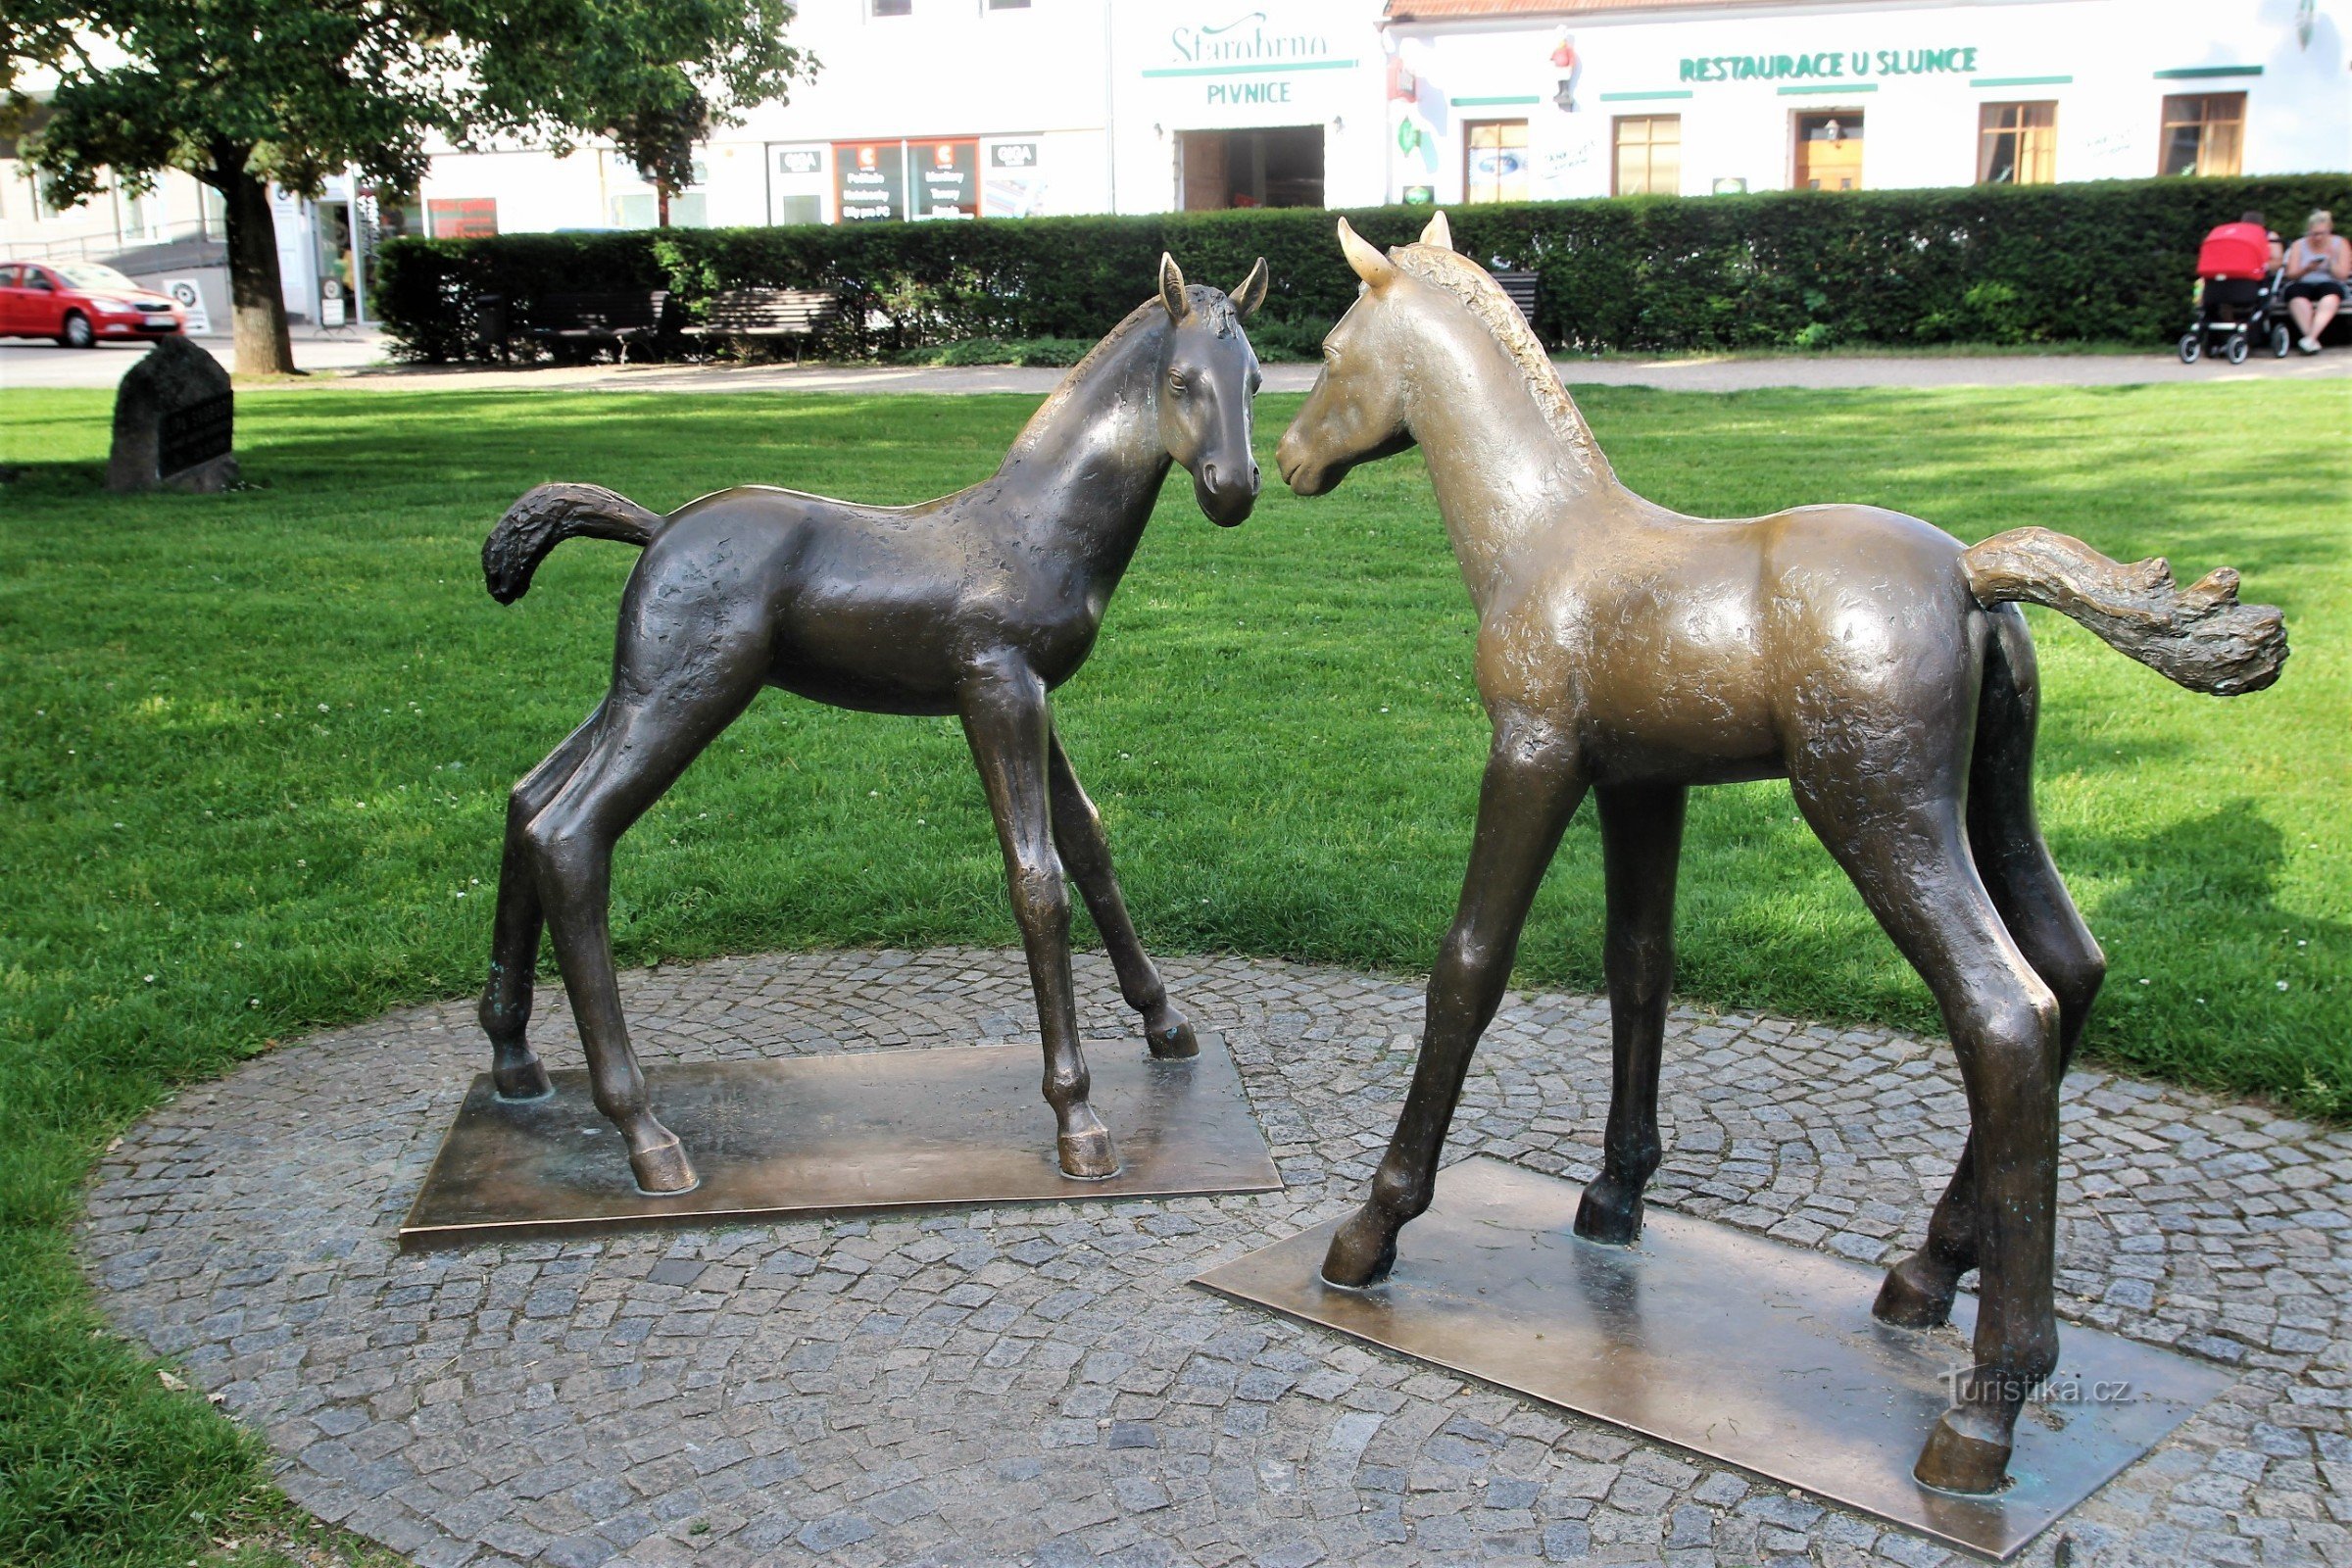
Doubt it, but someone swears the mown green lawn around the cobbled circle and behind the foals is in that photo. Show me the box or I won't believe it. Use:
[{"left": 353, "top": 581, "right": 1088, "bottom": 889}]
[{"left": 0, "top": 383, "right": 2352, "bottom": 1566}]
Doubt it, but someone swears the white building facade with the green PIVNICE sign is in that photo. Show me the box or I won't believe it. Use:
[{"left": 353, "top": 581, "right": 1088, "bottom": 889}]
[{"left": 421, "top": 0, "right": 1386, "bottom": 232}]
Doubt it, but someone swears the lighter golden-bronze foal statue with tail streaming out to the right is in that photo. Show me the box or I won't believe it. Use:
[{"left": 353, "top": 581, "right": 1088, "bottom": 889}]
[{"left": 1277, "top": 214, "right": 2286, "bottom": 1493}]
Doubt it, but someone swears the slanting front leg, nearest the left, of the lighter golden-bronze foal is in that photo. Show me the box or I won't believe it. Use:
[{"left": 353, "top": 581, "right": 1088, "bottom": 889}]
[{"left": 1322, "top": 721, "right": 1586, "bottom": 1289}]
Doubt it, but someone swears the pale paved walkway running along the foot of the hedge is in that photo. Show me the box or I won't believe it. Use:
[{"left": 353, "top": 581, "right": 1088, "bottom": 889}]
[{"left": 0, "top": 334, "right": 2352, "bottom": 397}]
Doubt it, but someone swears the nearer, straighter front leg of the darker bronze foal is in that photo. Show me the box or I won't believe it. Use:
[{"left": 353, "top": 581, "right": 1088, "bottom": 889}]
[{"left": 957, "top": 654, "right": 1119, "bottom": 1180}]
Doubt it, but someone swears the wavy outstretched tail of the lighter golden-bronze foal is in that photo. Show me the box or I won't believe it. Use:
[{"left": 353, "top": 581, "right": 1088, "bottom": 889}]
[{"left": 1959, "top": 529, "right": 2286, "bottom": 696}]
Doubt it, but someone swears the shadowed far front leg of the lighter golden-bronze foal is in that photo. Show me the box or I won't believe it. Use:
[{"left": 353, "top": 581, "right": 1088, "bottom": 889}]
[{"left": 1576, "top": 785, "right": 1691, "bottom": 1246}]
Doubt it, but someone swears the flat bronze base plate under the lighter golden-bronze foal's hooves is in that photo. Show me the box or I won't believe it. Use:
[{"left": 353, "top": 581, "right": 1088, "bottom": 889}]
[{"left": 1195, "top": 1156, "right": 2232, "bottom": 1561}]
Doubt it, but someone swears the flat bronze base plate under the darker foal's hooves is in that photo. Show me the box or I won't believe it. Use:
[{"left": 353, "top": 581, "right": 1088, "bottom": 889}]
[{"left": 400, "top": 1030, "right": 1282, "bottom": 1250}]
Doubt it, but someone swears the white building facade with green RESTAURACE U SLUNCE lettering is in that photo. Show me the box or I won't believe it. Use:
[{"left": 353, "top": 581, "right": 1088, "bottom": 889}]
[{"left": 1386, "top": 0, "right": 2352, "bottom": 207}]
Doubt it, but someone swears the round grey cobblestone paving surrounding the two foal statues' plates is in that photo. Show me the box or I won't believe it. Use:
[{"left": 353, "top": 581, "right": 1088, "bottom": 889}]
[{"left": 84, "top": 950, "right": 2352, "bottom": 1568}]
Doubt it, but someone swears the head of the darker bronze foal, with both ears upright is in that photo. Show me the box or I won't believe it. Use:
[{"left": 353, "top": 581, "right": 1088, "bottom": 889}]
[{"left": 1157, "top": 254, "right": 1265, "bottom": 529}]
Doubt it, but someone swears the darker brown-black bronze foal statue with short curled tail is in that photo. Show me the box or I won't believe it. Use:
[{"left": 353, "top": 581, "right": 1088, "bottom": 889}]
[{"left": 466, "top": 256, "right": 1265, "bottom": 1192}]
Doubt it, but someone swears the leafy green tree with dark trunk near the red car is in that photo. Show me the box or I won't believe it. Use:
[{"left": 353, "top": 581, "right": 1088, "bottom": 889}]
[{"left": 0, "top": 0, "right": 813, "bottom": 373}]
